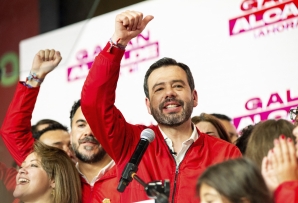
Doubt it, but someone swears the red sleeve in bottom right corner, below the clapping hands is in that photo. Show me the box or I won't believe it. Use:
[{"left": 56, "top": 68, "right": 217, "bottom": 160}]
[{"left": 274, "top": 181, "right": 298, "bottom": 203}]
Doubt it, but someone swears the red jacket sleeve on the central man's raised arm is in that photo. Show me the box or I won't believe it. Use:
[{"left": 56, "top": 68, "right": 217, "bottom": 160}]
[{"left": 81, "top": 43, "right": 142, "bottom": 163}]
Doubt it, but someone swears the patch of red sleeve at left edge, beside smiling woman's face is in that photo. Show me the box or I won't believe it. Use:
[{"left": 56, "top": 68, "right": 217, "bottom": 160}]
[{"left": 0, "top": 163, "right": 18, "bottom": 192}]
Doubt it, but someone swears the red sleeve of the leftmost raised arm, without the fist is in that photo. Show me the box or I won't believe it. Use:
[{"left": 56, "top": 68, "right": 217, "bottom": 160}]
[{"left": 1, "top": 82, "right": 39, "bottom": 165}]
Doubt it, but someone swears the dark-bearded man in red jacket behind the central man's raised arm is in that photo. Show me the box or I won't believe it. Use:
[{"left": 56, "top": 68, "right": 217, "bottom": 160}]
[{"left": 70, "top": 100, "right": 120, "bottom": 203}]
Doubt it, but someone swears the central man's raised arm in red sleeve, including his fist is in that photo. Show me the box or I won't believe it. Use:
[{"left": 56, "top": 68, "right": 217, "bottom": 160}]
[{"left": 81, "top": 11, "right": 153, "bottom": 162}]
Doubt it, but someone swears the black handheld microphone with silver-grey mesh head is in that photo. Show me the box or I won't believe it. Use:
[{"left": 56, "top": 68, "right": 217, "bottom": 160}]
[{"left": 117, "top": 128, "right": 155, "bottom": 192}]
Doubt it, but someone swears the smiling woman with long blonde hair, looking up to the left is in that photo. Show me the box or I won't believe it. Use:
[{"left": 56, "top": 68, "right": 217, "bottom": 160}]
[{"left": 13, "top": 141, "right": 81, "bottom": 203}]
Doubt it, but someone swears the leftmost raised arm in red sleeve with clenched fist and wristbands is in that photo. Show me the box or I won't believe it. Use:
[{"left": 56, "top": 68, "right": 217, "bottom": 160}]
[{"left": 1, "top": 49, "right": 62, "bottom": 165}]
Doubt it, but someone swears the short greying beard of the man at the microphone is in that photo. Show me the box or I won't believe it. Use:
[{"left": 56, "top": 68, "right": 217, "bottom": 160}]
[{"left": 150, "top": 99, "right": 193, "bottom": 127}]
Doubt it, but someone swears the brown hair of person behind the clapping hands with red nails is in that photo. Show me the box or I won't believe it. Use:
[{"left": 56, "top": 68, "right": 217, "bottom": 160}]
[{"left": 245, "top": 119, "right": 295, "bottom": 169}]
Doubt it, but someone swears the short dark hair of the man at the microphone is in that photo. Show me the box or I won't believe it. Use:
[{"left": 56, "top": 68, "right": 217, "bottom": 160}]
[{"left": 143, "top": 57, "right": 195, "bottom": 99}]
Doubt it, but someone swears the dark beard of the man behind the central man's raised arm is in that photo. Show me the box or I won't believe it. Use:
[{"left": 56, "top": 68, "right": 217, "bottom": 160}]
[{"left": 72, "top": 143, "right": 106, "bottom": 164}]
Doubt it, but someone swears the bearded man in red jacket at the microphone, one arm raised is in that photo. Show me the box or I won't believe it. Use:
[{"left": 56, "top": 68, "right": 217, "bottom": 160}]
[{"left": 81, "top": 11, "right": 241, "bottom": 203}]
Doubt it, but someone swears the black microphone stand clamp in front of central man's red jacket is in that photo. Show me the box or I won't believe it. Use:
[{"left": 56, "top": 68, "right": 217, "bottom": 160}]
[{"left": 131, "top": 173, "right": 170, "bottom": 203}]
